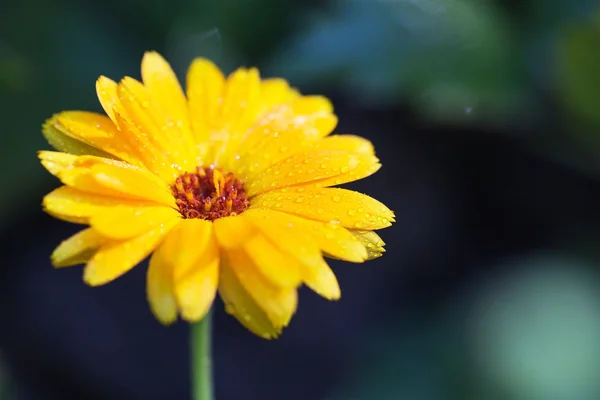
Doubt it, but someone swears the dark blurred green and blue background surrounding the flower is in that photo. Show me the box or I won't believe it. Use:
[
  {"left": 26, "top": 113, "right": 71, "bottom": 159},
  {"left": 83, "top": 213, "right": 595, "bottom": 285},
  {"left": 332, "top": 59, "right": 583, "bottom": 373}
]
[{"left": 0, "top": 0, "right": 600, "bottom": 400}]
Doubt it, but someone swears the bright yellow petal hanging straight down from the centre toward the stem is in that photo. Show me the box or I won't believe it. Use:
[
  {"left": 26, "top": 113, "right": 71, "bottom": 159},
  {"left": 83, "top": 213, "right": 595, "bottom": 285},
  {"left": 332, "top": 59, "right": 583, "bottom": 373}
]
[{"left": 159, "top": 219, "right": 219, "bottom": 322}]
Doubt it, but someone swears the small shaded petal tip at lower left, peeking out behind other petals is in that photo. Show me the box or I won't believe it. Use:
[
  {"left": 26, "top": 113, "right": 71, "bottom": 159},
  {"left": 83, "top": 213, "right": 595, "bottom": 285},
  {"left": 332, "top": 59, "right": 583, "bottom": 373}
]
[{"left": 50, "top": 228, "right": 107, "bottom": 267}]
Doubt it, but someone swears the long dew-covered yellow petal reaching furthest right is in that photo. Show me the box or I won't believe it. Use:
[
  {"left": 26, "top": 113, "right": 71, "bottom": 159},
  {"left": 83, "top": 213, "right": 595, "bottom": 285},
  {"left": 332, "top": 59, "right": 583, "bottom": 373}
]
[{"left": 252, "top": 186, "right": 394, "bottom": 230}]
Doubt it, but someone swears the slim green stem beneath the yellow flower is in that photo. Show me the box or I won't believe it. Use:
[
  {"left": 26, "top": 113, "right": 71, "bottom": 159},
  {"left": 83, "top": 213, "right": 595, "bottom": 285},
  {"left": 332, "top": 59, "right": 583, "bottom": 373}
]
[{"left": 190, "top": 311, "right": 214, "bottom": 400}]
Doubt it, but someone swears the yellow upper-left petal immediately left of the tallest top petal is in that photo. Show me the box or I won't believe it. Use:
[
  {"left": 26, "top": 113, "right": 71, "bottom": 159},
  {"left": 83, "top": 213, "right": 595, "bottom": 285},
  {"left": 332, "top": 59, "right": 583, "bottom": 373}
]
[{"left": 117, "top": 77, "right": 196, "bottom": 169}]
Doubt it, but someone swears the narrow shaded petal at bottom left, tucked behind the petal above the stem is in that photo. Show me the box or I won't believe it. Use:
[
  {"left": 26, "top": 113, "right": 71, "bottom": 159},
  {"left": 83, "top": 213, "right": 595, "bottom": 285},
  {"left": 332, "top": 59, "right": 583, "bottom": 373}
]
[{"left": 146, "top": 250, "right": 177, "bottom": 325}]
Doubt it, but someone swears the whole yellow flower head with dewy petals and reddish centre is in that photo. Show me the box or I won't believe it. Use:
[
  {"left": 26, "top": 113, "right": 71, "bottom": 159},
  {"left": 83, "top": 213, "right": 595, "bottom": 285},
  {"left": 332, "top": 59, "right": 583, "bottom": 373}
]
[{"left": 39, "top": 52, "right": 394, "bottom": 338}]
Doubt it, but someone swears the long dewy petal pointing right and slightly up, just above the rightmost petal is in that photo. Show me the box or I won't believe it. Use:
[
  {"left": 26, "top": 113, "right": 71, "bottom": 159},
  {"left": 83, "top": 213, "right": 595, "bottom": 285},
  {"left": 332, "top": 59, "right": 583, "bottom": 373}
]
[{"left": 246, "top": 151, "right": 376, "bottom": 197}]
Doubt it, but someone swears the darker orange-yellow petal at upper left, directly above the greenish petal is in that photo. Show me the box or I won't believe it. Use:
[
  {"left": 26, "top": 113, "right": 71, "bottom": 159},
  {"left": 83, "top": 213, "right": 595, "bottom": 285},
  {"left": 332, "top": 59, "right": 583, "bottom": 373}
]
[{"left": 44, "top": 111, "right": 144, "bottom": 166}]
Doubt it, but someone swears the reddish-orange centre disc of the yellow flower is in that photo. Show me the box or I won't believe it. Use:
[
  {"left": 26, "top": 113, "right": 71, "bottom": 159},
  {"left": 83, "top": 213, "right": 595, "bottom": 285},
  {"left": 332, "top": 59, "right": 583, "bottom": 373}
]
[{"left": 171, "top": 167, "right": 249, "bottom": 221}]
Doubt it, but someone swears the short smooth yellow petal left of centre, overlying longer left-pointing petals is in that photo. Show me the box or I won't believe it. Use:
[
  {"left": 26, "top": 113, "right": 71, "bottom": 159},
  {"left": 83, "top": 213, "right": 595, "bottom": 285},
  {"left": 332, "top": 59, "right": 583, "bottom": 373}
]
[{"left": 90, "top": 205, "right": 181, "bottom": 239}]
